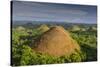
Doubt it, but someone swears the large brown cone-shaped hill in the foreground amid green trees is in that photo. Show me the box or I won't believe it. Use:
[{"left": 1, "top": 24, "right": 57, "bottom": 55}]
[{"left": 33, "top": 26, "right": 80, "bottom": 56}]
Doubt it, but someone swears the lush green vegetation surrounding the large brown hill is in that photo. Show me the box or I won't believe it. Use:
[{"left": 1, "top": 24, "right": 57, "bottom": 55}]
[{"left": 12, "top": 23, "right": 97, "bottom": 66}]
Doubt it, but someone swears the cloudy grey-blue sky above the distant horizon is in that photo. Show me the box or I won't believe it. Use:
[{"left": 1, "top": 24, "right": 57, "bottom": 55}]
[{"left": 12, "top": 1, "right": 97, "bottom": 24}]
